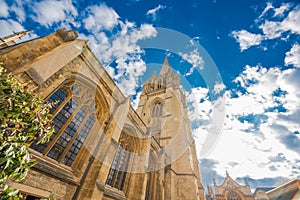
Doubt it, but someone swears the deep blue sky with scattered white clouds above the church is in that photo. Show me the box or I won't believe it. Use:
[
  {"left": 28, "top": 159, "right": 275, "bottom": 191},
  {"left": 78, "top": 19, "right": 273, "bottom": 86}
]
[{"left": 0, "top": 0, "right": 300, "bottom": 191}]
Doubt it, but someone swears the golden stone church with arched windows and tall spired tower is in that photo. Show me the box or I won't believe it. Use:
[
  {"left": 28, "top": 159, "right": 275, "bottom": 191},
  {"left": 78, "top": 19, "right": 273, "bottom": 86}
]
[{"left": 0, "top": 29, "right": 205, "bottom": 200}]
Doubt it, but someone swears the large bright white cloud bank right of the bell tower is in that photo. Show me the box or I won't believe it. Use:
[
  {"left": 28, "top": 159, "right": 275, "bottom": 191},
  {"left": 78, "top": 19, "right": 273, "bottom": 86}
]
[{"left": 191, "top": 66, "right": 300, "bottom": 179}]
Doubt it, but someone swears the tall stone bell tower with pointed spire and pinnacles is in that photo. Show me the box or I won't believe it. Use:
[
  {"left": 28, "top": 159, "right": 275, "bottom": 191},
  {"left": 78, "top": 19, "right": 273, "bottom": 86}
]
[{"left": 137, "top": 57, "right": 205, "bottom": 200}]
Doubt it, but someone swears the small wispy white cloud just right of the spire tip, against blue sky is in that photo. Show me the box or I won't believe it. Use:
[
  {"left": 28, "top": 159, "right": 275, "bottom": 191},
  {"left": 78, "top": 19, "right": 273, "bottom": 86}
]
[{"left": 179, "top": 49, "right": 204, "bottom": 76}]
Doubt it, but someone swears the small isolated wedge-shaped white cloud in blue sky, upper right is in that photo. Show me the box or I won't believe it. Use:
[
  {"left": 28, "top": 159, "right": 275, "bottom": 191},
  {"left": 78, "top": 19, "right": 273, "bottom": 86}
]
[{"left": 232, "top": 30, "right": 263, "bottom": 51}]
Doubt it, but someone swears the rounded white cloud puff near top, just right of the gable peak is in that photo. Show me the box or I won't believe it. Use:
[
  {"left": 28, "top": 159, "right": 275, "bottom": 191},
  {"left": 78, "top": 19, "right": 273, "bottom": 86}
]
[{"left": 83, "top": 4, "right": 119, "bottom": 34}]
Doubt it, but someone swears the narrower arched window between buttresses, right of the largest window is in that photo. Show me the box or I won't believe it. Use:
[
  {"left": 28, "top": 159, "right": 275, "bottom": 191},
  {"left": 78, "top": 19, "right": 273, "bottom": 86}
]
[{"left": 106, "top": 133, "right": 133, "bottom": 190}]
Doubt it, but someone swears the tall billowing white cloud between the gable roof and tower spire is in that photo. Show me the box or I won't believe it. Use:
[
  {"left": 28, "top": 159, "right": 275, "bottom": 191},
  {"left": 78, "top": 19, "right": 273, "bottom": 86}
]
[{"left": 80, "top": 4, "right": 157, "bottom": 96}]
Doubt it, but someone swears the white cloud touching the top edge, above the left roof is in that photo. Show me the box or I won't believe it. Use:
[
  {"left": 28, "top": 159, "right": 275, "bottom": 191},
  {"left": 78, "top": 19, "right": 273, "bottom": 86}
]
[{"left": 32, "top": 0, "right": 78, "bottom": 27}]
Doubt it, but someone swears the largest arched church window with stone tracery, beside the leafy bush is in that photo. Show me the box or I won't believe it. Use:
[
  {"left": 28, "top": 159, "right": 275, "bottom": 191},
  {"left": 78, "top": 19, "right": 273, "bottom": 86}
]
[{"left": 31, "top": 82, "right": 96, "bottom": 166}]
